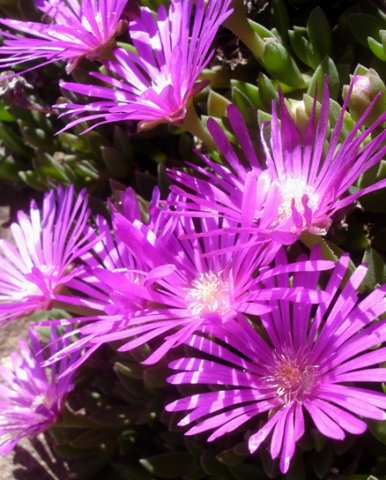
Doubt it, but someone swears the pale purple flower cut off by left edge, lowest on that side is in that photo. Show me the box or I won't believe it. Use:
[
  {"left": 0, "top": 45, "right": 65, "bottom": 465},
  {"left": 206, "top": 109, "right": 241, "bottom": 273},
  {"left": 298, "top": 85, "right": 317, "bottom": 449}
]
[{"left": 0, "top": 328, "right": 78, "bottom": 455}]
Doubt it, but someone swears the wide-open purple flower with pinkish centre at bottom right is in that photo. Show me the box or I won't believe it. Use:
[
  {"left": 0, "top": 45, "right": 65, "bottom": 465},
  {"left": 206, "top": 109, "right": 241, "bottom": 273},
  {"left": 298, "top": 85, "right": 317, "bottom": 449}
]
[{"left": 166, "top": 256, "right": 386, "bottom": 473}]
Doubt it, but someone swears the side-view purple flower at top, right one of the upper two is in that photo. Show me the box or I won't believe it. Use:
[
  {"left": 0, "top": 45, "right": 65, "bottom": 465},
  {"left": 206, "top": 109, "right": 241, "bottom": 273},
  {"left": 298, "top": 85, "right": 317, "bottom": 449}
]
[{"left": 58, "top": 0, "right": 231, "bottom": 128}]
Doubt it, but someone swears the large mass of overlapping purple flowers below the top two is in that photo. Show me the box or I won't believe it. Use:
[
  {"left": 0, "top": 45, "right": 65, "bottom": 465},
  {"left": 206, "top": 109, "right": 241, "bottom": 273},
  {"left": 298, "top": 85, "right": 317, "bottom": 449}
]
[{"left": 0, "top": 85, "right": 386, "bottom": 472}]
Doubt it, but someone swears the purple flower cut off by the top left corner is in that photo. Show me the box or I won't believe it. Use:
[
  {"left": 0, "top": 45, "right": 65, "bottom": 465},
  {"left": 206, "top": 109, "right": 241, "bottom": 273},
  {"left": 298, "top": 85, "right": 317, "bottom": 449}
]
[{"left": 0, "top": 0, "right": 127, "bottom": 73}]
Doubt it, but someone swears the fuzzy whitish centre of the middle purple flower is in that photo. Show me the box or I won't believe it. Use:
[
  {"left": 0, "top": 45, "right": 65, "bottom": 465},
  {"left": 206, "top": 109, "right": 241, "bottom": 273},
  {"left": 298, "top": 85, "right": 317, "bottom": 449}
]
[{"left": 186, "top": 272, "right": 230, "bottom": 315}]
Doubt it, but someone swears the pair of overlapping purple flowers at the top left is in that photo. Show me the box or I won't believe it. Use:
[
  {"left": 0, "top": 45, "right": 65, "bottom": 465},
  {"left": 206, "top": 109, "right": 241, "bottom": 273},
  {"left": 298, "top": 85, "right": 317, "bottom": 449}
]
[{"left": 0, "top": 0, "right": 232, "bottom": 128}]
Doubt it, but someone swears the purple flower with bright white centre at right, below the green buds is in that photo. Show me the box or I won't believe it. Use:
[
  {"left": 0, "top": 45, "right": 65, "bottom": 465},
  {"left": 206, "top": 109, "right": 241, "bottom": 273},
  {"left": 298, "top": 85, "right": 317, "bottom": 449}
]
[{"left": 170, "top": 78, "right": 386, "bottom": 244}]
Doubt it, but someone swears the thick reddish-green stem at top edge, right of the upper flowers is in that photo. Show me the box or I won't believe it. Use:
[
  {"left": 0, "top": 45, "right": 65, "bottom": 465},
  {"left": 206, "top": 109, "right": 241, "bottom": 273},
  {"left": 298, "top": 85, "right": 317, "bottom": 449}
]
[{"left": 224, "top": 0, "right": 265, "bottom": 60}]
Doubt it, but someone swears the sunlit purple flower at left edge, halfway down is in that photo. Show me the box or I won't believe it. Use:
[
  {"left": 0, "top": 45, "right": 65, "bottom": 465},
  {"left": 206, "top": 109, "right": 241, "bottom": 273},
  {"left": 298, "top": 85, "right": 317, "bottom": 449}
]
[{"left": 0, "top": 186, "right": 94, "bottom": 326}]
